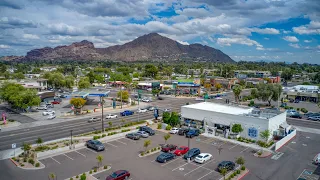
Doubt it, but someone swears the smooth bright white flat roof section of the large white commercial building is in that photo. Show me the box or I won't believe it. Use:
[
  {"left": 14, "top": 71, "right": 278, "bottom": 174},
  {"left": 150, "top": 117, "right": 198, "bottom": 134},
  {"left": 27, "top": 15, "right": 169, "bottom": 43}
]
[{"left": 182, "top": 102, "right": 254, "bottom": 115}]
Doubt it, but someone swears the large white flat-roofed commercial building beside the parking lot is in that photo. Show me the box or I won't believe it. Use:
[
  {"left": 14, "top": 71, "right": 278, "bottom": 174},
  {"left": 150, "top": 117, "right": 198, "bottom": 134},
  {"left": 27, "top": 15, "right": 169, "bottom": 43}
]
[{"left": 181, "top": 102, "right": 291, "bottom": 140}]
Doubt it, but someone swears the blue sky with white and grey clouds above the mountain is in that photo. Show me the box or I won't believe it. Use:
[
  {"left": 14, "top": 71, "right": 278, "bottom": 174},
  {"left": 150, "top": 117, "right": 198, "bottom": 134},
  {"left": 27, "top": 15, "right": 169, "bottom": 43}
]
[{"left": 0, "top": 0, "right": 320, "bottom": 64}]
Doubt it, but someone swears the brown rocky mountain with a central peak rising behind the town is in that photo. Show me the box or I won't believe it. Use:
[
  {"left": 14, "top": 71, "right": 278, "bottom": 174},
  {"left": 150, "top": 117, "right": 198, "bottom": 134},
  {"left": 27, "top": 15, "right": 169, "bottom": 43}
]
[{"left": 23, "top": 33, "right": 234, "bottom": 62}]
